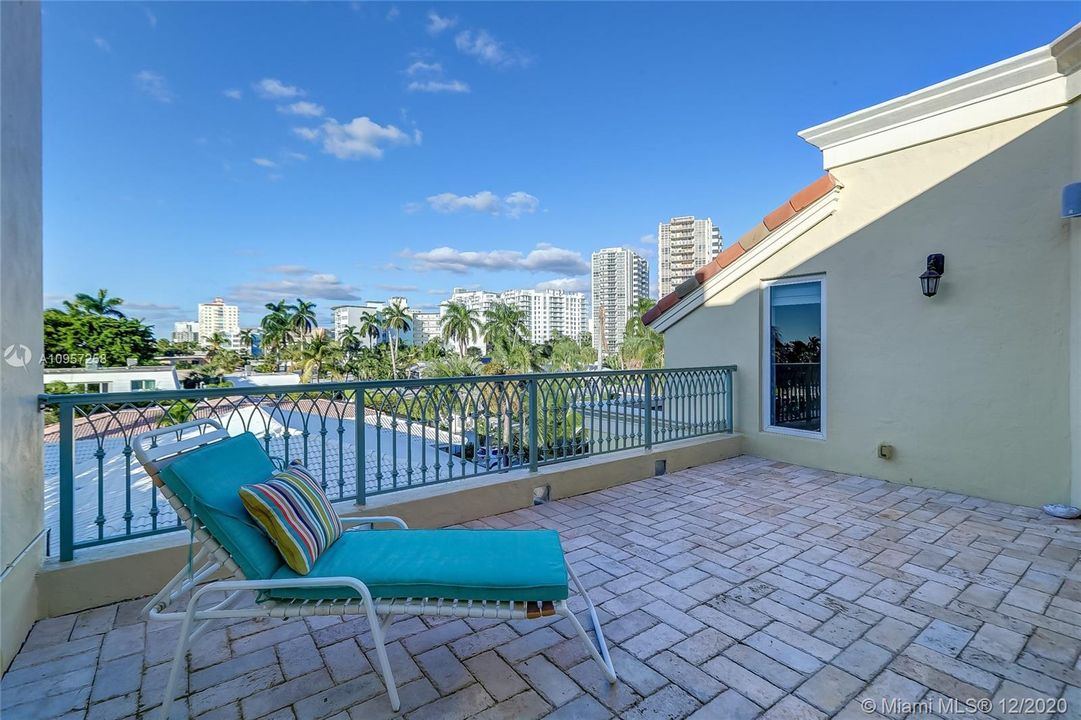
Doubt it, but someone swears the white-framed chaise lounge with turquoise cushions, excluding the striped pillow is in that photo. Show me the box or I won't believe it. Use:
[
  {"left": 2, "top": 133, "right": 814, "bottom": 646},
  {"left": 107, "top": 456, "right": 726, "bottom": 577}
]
[{"left": 135, "top": 419, "right": 616, "bottom": 720}]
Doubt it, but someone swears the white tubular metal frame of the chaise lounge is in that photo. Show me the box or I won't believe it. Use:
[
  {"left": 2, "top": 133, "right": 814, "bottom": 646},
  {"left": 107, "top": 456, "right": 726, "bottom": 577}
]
[{"left": 134, "top": 418, "right": 616, "bottom": 720}]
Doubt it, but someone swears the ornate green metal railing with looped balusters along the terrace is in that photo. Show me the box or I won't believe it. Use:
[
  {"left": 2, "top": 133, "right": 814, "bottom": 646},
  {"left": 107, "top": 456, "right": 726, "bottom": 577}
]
[{"left": 41, "top": 366, "right": 735, "bottom": 560}]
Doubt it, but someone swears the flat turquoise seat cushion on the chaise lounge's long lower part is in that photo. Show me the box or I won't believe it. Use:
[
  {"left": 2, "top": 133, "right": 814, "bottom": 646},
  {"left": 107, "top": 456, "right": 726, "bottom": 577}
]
[{"left": 269, "top": 530, "right": 568, "bottom": 601}]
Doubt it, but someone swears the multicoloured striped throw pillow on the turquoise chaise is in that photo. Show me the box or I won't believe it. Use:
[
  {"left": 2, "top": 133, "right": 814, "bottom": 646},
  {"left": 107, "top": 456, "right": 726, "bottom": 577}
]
[{"left": 240, "top": 465, "right": 342, "bottom": 575}]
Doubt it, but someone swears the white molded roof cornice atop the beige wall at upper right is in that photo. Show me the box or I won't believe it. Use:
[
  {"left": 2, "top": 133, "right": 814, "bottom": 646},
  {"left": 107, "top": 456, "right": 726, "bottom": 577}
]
[{"left": 798, "top": 23, "right": 1081, "bottom": 169}]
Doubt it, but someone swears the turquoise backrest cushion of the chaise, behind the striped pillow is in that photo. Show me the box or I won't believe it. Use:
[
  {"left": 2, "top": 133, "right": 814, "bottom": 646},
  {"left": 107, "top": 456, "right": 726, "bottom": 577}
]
[{"left": 161, "top": 432, "right": 282, "bottom": 579}]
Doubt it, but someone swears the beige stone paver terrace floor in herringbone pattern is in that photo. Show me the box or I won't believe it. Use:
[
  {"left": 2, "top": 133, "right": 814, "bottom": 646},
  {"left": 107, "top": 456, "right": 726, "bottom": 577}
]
[{"left": 6, "top": 456, "right": 1081, "bottom": 720}]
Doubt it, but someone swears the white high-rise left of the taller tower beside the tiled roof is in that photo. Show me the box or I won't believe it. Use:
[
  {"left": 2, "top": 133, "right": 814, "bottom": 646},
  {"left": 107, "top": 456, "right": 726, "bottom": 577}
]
[{"left": 591, "top": 248, "right": 650, "bottom": 359}]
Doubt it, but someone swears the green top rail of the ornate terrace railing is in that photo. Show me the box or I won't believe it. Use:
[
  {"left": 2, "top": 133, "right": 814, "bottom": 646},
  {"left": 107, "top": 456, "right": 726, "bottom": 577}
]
[{"left": 38, "top": 365, "right": 736, "bottom": 406}]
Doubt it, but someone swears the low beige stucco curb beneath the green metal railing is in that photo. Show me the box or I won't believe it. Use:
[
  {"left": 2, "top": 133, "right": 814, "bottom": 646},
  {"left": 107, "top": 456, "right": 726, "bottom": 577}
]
[{"left": 38, "top": 435, "right": 743, "bottom": 617}]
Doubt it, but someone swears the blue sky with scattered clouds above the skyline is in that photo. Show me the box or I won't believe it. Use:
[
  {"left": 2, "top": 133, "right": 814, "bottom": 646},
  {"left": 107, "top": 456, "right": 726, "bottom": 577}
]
[{"left": 43, "top": 2, "right": 1078, "bottom": 335}]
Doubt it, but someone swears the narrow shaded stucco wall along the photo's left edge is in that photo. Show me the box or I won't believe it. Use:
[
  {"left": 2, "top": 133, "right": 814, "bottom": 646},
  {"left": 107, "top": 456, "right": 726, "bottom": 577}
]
[{"left": 0, "top": 2, "right": 43, "bottom": 669}]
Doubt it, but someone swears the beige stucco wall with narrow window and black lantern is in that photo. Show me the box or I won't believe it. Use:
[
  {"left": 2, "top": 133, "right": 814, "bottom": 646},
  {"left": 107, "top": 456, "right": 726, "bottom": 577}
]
[{"left": 665, "top": 108, "right": 1079, "bottom": 505}]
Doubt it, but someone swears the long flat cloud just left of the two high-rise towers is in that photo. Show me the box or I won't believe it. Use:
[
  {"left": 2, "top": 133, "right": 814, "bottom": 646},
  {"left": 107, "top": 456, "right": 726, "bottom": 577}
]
[{"left": 402, "top": 243, "right": 589, "bottom": 275}]
